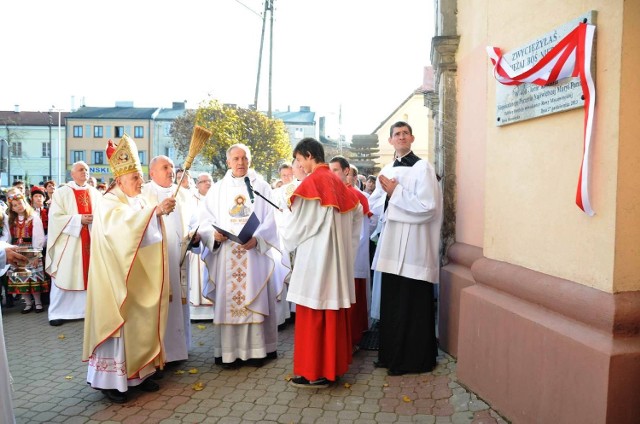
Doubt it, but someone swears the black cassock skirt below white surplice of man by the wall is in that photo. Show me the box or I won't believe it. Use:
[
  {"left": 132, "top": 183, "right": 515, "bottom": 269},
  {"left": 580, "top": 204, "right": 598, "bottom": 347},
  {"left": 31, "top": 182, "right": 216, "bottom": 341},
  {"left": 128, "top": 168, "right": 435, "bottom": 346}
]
[{"left": 378, "top": 273, "right": 438, "bottom": 372}]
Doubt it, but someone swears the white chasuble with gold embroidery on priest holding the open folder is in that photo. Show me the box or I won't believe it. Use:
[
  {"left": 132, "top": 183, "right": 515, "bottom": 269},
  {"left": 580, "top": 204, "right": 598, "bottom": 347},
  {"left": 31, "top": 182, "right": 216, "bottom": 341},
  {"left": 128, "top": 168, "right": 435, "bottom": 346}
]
[{"left": 199, "top": 170, "right": 282, "bottom": 324}]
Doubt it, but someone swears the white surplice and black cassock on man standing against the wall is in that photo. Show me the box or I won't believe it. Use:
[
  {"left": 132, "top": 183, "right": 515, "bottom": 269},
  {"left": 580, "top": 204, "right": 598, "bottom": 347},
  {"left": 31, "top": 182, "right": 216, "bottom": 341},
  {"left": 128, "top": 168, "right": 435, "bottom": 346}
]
[{"left": 369, "top": 152, "right": 442, "bottom": 373}]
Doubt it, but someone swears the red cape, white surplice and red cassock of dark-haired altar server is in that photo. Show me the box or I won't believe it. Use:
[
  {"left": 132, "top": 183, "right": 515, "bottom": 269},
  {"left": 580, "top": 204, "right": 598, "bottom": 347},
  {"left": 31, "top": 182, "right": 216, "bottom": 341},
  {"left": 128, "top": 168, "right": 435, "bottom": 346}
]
[{"left": 282, "top": 164, "right": 362, "bottom": 381}]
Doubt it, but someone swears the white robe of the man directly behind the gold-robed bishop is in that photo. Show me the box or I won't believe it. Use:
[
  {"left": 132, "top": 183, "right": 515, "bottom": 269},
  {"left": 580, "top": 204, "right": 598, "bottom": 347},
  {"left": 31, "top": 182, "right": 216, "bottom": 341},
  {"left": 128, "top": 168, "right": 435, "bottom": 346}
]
[{"left": 142, "top": 181, "right": 197, "bottom": 362}]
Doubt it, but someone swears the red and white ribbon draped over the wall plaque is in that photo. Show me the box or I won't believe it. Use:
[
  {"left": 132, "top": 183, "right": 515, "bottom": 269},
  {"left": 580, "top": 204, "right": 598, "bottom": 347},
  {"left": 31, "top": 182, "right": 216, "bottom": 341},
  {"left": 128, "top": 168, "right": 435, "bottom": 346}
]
[{"left": 487, "top": 23, "right": 596, "bottom": 216}]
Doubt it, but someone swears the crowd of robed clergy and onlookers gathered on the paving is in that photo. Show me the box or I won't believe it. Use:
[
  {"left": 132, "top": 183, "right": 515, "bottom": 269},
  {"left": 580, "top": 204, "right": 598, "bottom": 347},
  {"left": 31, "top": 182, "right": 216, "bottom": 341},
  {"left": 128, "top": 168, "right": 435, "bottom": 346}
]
[{"left": 0, "top": 122, "right": 442, "bottom": 403}]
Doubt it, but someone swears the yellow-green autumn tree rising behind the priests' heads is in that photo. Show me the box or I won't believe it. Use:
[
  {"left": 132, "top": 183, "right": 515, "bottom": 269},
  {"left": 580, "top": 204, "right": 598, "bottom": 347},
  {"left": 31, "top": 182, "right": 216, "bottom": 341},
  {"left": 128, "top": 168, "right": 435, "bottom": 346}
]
[{"left": 171, "top": 100, "right": 291, "bottom": 181}]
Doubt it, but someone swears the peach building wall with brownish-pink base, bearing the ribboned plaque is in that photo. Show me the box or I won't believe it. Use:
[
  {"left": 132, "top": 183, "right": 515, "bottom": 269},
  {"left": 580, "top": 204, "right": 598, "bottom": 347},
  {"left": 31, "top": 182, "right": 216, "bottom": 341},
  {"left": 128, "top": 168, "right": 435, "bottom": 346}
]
[{"left": 426, "top": 0, "right": 640, "bottom": 424}]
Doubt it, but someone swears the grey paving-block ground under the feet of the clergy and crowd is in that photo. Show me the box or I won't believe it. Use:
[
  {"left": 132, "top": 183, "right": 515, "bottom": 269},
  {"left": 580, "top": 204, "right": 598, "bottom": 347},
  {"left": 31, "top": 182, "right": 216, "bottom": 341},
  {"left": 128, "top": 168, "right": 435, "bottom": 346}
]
[{"left": 2, "top": 305, "right": 507, "bottom": 424}]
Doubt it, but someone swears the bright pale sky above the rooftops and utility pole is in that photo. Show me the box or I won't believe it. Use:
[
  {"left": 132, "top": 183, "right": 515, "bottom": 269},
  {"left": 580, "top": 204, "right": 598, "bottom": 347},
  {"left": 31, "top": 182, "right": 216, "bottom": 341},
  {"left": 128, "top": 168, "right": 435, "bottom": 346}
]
[{"left": 0, "top": 0, "right": 434, "bottom": 135}]
